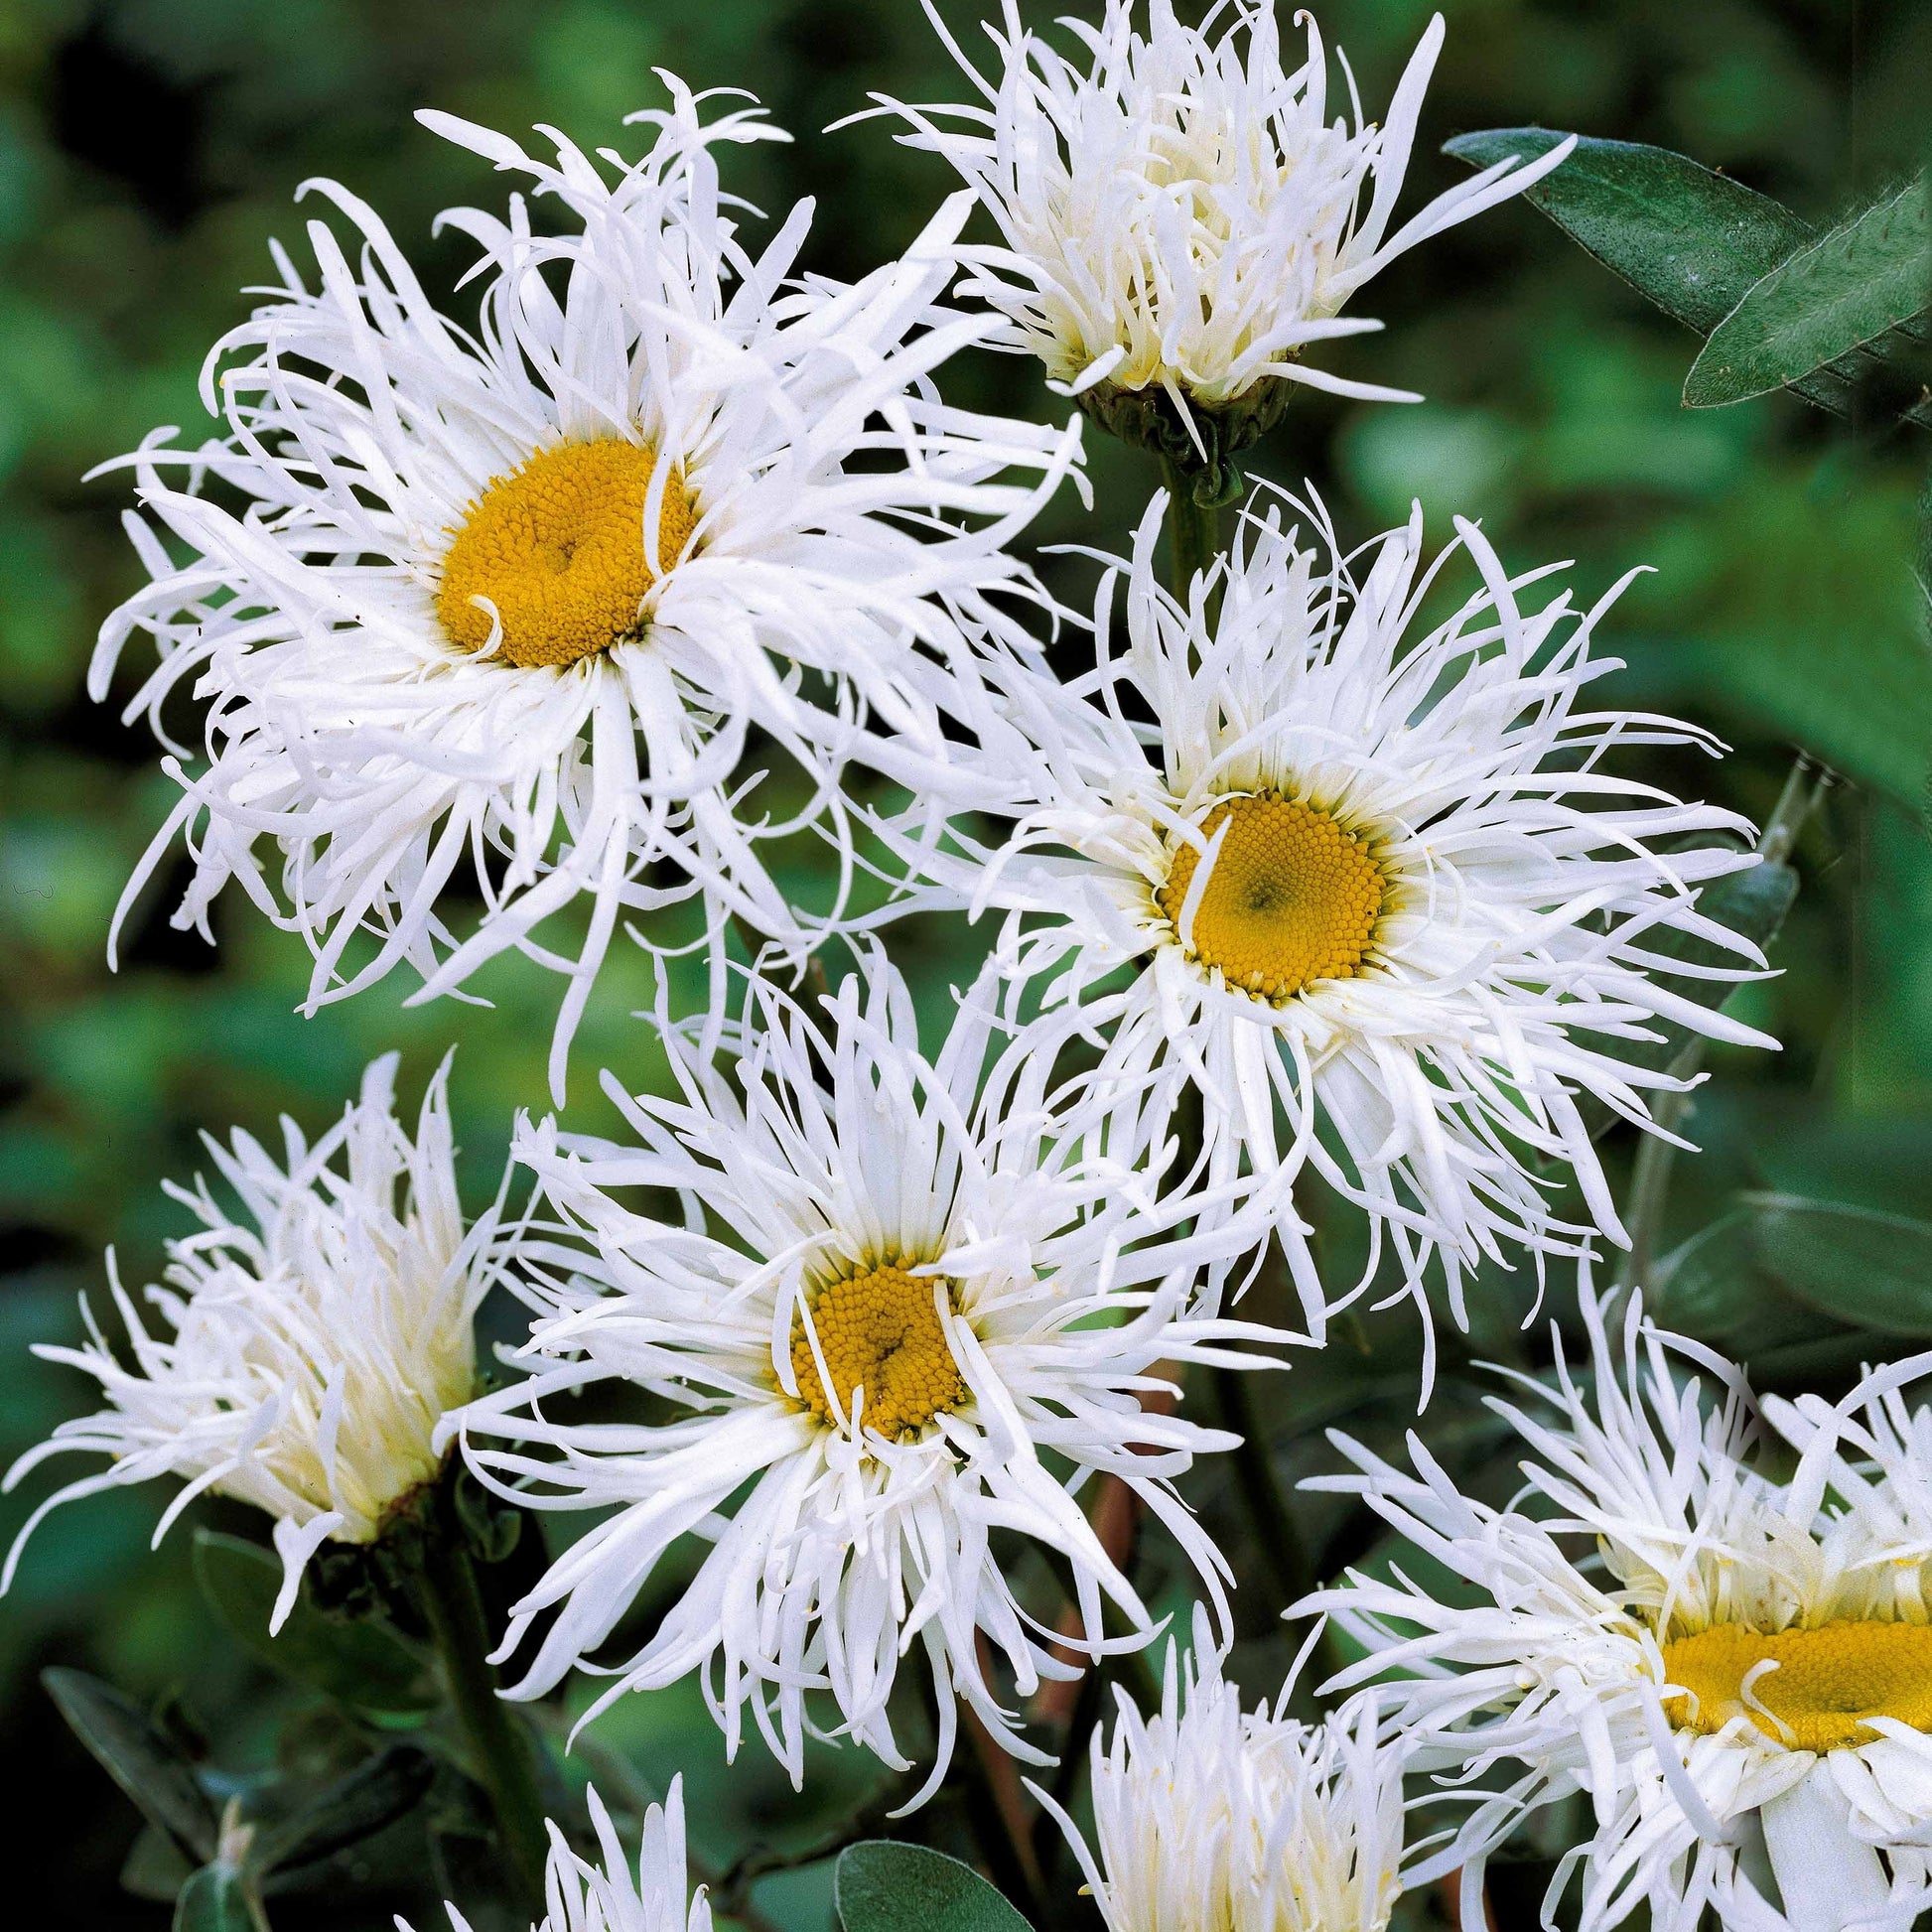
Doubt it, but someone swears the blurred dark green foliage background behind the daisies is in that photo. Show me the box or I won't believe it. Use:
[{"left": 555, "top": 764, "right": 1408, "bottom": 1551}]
[{"left": 0, "top": 0, "right": 1932, "bottom": 1932}]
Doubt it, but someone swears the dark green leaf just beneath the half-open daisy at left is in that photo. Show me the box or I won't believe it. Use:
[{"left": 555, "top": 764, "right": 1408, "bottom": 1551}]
[{"left": 196, "top": 1530, "right": 439, "bottom": 1718}]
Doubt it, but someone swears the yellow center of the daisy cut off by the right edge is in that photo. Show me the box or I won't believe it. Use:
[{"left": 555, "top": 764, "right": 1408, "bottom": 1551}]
[{"left": 1664, "top": 1621, "right": 1932, "bottom": 1750}]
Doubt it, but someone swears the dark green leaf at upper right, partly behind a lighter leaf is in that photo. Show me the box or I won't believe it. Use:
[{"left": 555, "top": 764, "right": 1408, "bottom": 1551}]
[{"left": 1444, "top": 127, "right": 1814, "bottom": 337}]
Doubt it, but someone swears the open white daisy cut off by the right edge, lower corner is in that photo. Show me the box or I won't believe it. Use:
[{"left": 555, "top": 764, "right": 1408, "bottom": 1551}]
[{"left": 1305, "top": 1281, "right": 1932, "bottom": 1932}]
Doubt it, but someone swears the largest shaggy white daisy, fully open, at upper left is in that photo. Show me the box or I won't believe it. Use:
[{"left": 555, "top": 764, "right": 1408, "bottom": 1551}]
[{"left": 90, "top": 79, "right": 1078, "bottom": 1097}]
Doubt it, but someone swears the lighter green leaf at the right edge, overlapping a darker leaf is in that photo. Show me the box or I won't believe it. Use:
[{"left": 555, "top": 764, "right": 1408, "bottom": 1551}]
[{"left": 1684, "top": 170, "right": 1932, "bottom": 410}]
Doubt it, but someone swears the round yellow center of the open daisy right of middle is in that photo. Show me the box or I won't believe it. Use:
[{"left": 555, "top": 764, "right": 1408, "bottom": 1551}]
[{"left": 1156, "top": 792, "right": 1387, "bottom": 1003}]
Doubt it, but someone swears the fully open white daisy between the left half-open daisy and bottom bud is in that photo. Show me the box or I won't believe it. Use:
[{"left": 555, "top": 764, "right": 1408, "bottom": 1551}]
[{"left": 456, "top": 960, "right": 1277, "bottom": 1803}]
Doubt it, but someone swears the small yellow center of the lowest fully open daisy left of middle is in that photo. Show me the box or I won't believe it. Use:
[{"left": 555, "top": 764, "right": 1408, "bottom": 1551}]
[{"left": 792, "top": 1262, "right": 968, "bottom": 1442}]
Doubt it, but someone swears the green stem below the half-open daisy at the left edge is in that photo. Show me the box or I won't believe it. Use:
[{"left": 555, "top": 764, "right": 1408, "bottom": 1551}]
[{"left": 417, "top": 1482, "right": 551, "bottom": 1918}]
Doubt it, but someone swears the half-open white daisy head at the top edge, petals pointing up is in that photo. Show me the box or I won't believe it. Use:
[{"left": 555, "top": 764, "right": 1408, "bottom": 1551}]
[{"left": 876, "top": 0, "right": 1569, "bottom": 419}]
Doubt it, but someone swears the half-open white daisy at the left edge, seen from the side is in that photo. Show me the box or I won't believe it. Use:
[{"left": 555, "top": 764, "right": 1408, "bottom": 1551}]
[{"left": 0, "top": 1053, "right": 508, "bottom": 1628}]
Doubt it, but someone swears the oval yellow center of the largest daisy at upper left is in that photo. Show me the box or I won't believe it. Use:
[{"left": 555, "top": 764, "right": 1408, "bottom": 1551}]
[{"left": 437, "top": 437, "right": 698, "bottom": 670}]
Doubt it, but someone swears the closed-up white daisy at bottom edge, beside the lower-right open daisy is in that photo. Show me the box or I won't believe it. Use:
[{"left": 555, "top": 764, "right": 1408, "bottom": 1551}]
[{"left": 1035, "top": 1615, "right": 1405, "bottom": 1932}]
